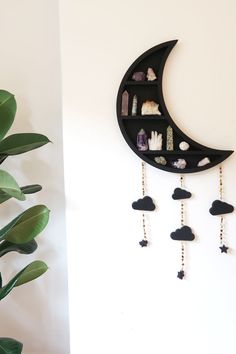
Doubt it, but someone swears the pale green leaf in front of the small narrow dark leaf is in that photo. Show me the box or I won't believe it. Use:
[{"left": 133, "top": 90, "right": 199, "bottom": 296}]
[{"left": 0, "top": 170, "right": 25, "bottom": 200}]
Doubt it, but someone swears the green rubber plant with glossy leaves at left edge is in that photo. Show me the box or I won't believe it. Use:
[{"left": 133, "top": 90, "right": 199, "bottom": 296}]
[{"left": 0, "top": 90, "right": 49, "bottom": 354}]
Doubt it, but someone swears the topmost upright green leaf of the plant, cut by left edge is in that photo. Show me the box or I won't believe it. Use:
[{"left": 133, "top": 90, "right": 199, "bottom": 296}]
[{"left": 0, "top": 90, "right": 16, "bottom": 141}]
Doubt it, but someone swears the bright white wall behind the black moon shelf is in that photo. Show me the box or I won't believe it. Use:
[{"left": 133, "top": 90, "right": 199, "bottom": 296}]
[{"left": 60, "top": 0, "right": 236, "bottom": 354}]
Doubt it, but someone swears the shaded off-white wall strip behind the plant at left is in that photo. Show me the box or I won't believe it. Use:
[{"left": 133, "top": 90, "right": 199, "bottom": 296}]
[{"left": 0, "top": 0, "right": 69, "bottom": 354}]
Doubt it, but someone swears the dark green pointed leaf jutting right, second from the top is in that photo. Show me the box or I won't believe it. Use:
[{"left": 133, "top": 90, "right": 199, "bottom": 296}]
[{"left": 0, "top": 133, "right": 50, "bottom": 155}]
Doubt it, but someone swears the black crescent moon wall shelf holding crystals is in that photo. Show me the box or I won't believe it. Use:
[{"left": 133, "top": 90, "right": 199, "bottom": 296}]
[{"left": 116, "top": 40, "right": 233, "bottom": 173}]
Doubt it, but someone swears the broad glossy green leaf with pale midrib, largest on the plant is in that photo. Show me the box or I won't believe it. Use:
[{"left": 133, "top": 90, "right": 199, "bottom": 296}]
[{"left": 0, "top": 205, "right": 50, "bottom": 244}]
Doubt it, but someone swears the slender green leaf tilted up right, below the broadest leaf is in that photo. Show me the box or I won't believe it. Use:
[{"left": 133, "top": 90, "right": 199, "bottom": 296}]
[{"left": 15, "top": 261, "right": 48, "bottom": 286}]
